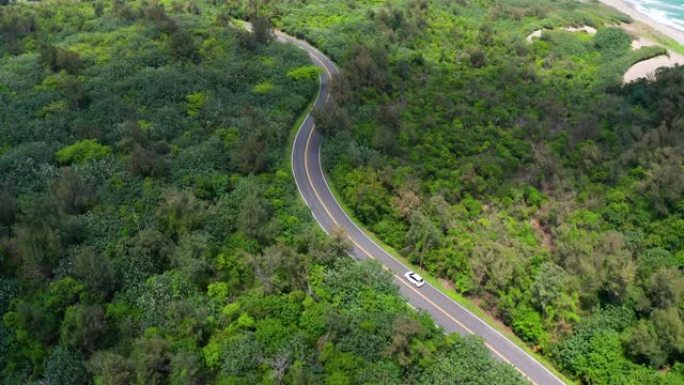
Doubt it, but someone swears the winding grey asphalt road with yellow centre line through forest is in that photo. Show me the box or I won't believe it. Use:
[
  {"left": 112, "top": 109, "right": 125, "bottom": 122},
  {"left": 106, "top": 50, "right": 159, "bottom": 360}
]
[{"left": 276, "top": 27, "right": 564, "bottom": 385}]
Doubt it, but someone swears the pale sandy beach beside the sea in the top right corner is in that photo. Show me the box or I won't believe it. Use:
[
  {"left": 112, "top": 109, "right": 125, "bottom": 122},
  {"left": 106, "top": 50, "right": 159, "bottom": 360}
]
[{"left": 599, "top": 0, "right": 684, "bottom": 83}]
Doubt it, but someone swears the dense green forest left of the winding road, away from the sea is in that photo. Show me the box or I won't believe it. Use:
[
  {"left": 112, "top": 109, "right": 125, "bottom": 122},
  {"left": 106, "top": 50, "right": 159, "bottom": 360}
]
[{"left": 0, "top": 0, "right": 524, "bottom": 385}]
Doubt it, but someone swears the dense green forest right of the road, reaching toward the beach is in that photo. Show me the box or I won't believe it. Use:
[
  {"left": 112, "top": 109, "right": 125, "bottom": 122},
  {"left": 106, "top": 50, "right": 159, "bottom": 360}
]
[{"left": 226, "top": 0, "right": 684, "bottom": 385}]
